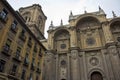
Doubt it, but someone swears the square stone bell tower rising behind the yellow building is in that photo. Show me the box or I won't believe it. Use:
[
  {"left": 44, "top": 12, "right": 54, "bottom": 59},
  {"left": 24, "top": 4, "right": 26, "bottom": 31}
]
[{"left": 19, "top": 4, "right": 47, "bottom": 40}]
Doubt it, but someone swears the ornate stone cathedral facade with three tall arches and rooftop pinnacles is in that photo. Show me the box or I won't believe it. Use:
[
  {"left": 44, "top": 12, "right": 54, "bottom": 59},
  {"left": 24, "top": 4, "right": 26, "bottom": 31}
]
[{"left": 43, "top": 7, "right": 120, "bottom": 80}]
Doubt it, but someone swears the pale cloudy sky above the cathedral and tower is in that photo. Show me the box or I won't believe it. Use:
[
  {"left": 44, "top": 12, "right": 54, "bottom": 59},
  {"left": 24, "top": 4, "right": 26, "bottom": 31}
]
[{"left": 7, "top": 0, "right": 120, "bottom": 37}]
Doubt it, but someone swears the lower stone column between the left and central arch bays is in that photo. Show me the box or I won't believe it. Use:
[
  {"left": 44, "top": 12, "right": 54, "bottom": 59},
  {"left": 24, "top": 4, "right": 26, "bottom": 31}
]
[{"left": 70, "top": 49, "right": 80, "bottom": 80}]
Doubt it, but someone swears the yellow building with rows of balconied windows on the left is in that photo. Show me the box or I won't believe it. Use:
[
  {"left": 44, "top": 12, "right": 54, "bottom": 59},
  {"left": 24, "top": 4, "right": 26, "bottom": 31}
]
[{"left": 0, "top": 0, "right": 46, "bottom": 80}]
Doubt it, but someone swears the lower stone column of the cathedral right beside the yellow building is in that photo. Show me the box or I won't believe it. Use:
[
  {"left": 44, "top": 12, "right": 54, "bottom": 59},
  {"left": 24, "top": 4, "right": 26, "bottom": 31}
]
[{"left": 45, "top": 51, "right": 56, "bottom": 80}]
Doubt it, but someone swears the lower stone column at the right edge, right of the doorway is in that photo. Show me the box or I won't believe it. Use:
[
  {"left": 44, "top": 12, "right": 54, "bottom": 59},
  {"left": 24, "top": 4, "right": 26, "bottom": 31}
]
[{"left": 107, "top": 43, "right": 120, "bottom": 80}]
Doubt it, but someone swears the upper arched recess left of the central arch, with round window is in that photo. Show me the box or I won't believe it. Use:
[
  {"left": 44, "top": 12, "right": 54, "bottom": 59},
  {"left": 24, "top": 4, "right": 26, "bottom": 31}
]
[{"left": 54, "top": 29, "right": 70, "bottom": 51}]
